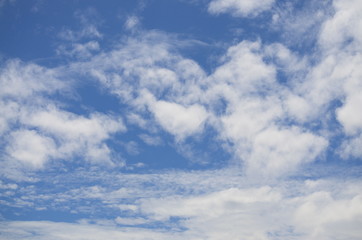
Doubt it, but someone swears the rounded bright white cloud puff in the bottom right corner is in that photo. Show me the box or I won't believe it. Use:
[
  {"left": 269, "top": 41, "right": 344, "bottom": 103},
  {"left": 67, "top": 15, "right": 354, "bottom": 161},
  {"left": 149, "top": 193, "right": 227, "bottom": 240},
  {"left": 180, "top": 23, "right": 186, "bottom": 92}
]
[{"left": 293, "top": 192, "right": 362, "bottom": 240}]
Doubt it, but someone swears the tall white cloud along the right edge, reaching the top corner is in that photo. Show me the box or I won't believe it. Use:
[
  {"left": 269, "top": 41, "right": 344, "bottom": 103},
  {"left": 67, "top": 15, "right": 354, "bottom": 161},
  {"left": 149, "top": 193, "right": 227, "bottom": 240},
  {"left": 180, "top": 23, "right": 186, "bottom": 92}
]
[{"left": 292, "top": 0, "right": 362, "bottom": 161}]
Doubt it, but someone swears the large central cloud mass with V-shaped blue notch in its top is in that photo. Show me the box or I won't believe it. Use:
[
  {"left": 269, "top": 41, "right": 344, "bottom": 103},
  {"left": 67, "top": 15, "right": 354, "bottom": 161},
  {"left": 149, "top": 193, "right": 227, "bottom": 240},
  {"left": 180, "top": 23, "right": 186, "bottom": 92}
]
[{"left": 71, "top": 32, "right": 328, "bottom": 177}]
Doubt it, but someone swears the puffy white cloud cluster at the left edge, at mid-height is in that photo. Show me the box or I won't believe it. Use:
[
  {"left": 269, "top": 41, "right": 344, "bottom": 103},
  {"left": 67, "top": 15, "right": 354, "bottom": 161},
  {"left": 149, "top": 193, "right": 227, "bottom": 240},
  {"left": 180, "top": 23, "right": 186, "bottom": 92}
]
[{"left": 0, "top": 60, "right": 126, "bottom": 178}]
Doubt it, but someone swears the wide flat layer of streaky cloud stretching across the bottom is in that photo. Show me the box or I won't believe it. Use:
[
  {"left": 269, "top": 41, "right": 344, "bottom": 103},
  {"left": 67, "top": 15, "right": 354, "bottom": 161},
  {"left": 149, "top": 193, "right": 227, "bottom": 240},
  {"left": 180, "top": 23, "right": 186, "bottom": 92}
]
[{"left": 0, "top": 166, "right": 362, "bottom": 240}]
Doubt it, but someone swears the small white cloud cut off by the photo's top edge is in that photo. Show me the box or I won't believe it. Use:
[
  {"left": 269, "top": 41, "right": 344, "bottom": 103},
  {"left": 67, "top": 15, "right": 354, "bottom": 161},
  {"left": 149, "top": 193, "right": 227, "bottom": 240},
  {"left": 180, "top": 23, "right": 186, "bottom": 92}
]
[{"left": 208, "top": 0, "right": 274, "bottom": 17}]
